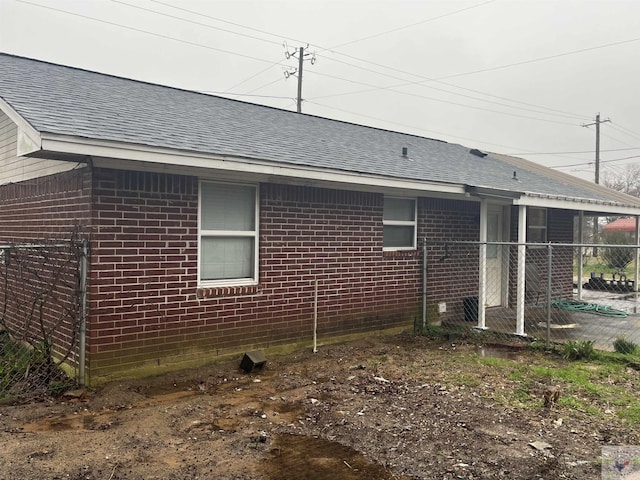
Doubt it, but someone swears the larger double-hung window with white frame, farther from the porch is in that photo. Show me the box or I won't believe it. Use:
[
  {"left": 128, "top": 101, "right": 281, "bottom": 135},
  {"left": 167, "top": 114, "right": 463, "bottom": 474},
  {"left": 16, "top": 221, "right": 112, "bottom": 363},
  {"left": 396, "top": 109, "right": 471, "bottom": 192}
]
[{"left": 198, "top": 182, "right": 258, "bottom": 285}]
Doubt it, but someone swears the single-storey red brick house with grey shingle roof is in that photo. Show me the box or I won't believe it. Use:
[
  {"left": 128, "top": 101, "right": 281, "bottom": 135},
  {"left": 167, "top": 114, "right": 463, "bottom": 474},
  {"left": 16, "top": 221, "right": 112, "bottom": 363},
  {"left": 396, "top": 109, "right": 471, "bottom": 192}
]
[{"left": 0, "top": 54, "right": 640, "bottom": 381}]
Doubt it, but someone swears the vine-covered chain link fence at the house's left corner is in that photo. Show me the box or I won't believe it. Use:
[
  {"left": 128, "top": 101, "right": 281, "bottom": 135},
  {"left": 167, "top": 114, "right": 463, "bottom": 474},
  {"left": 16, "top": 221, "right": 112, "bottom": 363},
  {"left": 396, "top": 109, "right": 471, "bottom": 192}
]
[{"left": 0, "top": 242, "right": 86, "bottom": 400}]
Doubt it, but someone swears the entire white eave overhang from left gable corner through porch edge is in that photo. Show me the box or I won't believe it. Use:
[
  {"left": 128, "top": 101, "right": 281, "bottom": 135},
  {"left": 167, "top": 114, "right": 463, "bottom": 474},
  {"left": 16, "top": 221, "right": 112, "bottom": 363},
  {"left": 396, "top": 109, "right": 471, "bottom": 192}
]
[{"left": 16, "top": 129, "right": 640, "bottom": 215}]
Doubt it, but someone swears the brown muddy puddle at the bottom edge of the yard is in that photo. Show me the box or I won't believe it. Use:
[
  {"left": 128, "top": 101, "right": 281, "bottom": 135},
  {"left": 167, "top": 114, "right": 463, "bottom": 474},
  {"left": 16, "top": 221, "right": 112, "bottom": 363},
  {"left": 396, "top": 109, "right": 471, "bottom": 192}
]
[{"left": 264, "top": 434, "right": 401, "bottom": 480}]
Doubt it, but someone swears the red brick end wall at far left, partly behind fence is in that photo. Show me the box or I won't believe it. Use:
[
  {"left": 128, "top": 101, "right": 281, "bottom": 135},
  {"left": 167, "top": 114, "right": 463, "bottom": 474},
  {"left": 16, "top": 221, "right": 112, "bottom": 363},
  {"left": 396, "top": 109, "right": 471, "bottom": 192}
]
[{"left": 0, "top": 169, "right": 91, "bottom": 363}]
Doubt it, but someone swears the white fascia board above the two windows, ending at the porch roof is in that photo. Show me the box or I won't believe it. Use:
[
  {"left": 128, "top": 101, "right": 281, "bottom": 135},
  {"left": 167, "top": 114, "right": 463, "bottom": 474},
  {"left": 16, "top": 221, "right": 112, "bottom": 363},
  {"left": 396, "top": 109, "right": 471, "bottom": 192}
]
[{"left": 42, "top": 134, "right": 465, "bottom": 196}]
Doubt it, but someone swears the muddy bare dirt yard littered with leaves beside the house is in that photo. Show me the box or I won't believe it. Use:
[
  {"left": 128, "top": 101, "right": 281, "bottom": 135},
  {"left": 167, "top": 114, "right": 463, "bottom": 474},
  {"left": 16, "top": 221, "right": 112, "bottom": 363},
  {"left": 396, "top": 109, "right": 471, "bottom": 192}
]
[{"left": 0, "top": 334, "right": 640, "bottom": 480}]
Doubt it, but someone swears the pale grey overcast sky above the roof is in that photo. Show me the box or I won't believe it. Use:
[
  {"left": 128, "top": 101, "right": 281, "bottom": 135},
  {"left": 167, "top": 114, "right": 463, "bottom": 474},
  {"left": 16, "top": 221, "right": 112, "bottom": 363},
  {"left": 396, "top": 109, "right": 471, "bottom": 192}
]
[{"left": 0, "top": 0, "right": 640, "bottom": 180}]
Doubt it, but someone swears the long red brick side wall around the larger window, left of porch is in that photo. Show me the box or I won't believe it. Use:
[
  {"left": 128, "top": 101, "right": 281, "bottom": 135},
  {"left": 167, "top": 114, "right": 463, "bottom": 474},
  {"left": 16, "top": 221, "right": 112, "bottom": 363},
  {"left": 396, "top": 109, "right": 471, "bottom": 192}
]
[{"left": 89, "top": 170, "right": 428, "bottom": 374}]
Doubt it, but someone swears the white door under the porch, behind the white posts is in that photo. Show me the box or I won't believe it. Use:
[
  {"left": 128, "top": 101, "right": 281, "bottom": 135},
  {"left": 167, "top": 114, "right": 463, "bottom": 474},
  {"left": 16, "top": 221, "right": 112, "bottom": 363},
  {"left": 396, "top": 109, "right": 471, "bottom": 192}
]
[{"left": 486, "top": 205, "right": 505, "bottom": 307}]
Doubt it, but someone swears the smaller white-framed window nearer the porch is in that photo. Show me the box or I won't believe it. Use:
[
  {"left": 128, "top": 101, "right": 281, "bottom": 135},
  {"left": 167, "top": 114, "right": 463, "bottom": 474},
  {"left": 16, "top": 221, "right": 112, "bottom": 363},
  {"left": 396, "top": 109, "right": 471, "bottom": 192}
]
[{"left": 382, "top": 197, "right": 416, "bottom": 250}]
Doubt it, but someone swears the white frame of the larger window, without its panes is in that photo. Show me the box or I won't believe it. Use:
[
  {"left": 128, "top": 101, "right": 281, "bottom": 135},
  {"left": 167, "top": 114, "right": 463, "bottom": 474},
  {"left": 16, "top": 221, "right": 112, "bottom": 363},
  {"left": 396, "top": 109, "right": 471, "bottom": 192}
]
[{"left": 198, "top": 179, "right": 260, "bottom": 287}]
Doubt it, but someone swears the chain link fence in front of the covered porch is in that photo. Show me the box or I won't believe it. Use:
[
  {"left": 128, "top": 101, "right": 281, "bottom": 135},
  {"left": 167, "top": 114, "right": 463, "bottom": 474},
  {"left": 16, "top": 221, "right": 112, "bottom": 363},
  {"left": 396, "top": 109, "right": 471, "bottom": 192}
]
[{"left": 422, "top": 242, "right": 640, "bottom": 350}]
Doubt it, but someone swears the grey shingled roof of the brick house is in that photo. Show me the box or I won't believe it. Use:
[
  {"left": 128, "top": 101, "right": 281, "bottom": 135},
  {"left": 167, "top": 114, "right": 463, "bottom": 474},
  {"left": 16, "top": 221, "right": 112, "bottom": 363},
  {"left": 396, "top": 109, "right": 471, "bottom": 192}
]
[{"left": 0, "top": 53, "right": 640, "bottom": 213}]
